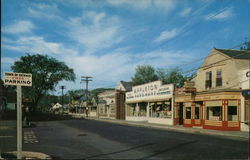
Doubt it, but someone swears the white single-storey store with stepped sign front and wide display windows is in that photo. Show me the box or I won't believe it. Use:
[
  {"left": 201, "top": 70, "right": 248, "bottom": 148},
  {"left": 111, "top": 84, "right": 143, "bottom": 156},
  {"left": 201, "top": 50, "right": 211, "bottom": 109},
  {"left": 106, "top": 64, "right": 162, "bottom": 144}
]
[{"left": 126, "top": 81, "right": 174, "bottom": 125}]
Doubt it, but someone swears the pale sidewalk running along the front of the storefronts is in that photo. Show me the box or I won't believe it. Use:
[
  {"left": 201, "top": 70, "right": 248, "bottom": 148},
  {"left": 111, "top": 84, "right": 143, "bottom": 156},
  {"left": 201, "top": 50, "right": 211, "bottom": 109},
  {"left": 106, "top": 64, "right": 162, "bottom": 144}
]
[{"left": 85, "top": 117, "right": 249, "bottom": 140}]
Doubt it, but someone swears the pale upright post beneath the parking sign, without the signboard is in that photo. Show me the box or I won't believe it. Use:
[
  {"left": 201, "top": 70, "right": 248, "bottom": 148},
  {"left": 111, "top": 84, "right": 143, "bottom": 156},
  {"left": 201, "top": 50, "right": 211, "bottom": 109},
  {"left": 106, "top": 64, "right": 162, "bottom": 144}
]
[{"left": 17, "top": 86, "right": 22, "bottom": 159}]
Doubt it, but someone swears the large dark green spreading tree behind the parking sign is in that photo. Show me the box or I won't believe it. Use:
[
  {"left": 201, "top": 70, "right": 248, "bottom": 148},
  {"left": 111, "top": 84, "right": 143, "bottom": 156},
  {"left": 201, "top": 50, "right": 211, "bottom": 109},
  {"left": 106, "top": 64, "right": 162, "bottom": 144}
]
[{"left": 11, "top": 54, "right": 76, "bottom": 112}]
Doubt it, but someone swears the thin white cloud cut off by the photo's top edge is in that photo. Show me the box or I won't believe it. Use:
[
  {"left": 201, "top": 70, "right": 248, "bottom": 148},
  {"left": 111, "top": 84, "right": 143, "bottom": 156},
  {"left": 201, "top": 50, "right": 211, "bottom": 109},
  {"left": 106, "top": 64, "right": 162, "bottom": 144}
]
[{"left": 107, "top": 0, "right": 177, "bottom": 11}]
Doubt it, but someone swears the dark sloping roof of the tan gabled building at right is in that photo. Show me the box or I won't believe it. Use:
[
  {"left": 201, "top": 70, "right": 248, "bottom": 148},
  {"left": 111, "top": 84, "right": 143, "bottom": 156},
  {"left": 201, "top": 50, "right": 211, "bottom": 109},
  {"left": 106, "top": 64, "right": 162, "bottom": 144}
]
[{"left": 216, "top": 48, "right": 250, "bottom": 60}]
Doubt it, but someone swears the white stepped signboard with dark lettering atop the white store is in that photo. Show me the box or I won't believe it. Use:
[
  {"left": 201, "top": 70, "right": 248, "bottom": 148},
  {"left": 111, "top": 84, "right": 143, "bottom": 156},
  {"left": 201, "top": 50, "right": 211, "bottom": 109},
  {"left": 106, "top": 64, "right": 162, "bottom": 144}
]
[{"left": 126, "top": 81, "right": 174, "bottom": 102}]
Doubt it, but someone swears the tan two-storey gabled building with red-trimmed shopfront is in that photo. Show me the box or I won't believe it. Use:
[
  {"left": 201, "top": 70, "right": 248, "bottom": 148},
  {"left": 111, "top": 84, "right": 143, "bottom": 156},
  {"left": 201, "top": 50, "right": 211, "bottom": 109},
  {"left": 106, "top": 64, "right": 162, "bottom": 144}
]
[{"left": 175, "top": 49, "right": 250, "bottom": 131}]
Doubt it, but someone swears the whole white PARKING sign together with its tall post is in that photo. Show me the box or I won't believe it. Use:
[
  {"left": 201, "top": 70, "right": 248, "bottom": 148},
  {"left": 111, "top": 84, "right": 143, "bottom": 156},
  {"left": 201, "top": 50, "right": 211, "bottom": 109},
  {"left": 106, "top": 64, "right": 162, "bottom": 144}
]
[{"left": 4, "top": 72, "right": 32, "bottom": 159}]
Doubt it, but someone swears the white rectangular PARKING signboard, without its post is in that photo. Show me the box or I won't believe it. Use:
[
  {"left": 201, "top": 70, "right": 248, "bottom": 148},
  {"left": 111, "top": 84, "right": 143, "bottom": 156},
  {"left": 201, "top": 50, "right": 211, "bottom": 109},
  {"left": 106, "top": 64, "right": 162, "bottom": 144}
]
[{"left": 4, "top": 72, "right": 32, "bottom": 86}]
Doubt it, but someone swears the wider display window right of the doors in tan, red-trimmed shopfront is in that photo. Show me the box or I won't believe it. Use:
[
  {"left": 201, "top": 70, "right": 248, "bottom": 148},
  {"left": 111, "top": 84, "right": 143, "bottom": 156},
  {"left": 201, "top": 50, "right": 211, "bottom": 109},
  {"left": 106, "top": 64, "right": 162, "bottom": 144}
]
[{"left": 207, "top": 106, "right": 222, "bottom": 121}]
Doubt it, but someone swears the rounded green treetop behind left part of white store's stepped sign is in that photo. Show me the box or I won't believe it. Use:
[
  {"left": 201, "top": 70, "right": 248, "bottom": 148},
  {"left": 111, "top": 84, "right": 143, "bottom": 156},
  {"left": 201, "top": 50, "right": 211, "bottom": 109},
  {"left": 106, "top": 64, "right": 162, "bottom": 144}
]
[{"left": 131, "top": 65, "right": 158, "bottom": 85}]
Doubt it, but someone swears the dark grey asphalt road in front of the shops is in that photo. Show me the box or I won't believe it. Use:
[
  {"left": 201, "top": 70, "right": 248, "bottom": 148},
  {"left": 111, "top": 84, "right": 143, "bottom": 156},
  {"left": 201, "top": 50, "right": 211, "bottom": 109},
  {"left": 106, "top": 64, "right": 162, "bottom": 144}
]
[{"left": 24, "top": 120, "right": 249, "bottom": 160}]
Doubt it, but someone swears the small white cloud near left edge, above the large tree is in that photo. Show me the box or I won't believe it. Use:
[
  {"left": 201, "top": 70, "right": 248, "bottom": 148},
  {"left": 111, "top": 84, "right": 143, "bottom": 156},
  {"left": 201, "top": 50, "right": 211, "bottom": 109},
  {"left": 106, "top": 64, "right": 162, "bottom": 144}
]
[{"left": 3, "top": 20, "right": 35, "bottom": 34}]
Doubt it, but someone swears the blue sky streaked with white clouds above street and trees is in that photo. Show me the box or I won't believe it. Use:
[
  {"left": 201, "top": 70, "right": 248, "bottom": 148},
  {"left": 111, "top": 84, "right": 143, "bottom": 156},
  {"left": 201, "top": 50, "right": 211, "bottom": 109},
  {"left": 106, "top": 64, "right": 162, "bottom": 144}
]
[{"left": 1, "top": 0, "right": 250, "bottom": 94}]
